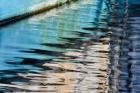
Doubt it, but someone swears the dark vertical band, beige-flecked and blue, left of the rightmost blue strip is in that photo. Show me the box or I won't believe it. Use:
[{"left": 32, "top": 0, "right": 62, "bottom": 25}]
[{"left": 110, "top": 0, "right": 129, "bottom": 93}]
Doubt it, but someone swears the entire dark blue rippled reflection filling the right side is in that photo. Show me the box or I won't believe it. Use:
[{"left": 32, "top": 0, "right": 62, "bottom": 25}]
[{"left": 109, "top": 0, "right": 140, "bottom": 93}]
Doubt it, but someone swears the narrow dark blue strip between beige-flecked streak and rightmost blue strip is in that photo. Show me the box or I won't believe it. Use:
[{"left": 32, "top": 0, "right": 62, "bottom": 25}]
[{"left": 119, "top": 0, "right": 131, "bottom": 93}]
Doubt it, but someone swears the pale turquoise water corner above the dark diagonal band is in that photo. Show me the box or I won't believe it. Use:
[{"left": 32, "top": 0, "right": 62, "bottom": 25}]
[{"left": 0, "top": 0, "right": 48, "bottom": 19}]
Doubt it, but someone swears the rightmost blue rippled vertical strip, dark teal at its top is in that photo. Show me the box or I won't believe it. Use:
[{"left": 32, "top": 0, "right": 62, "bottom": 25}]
[{"left": 128, "top": 0, "right": 140, "bottom": 93}]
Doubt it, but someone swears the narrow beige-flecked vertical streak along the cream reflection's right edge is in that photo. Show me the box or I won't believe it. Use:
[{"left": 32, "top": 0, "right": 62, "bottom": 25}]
[{"left": 109, "top": 0, "right": 121, "bottom": 93}]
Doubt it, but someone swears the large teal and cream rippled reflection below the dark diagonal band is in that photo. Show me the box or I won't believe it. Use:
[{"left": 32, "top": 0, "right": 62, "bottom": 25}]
[{"left": 0, "top": 0, "right": 109, "bottom": 93}]
